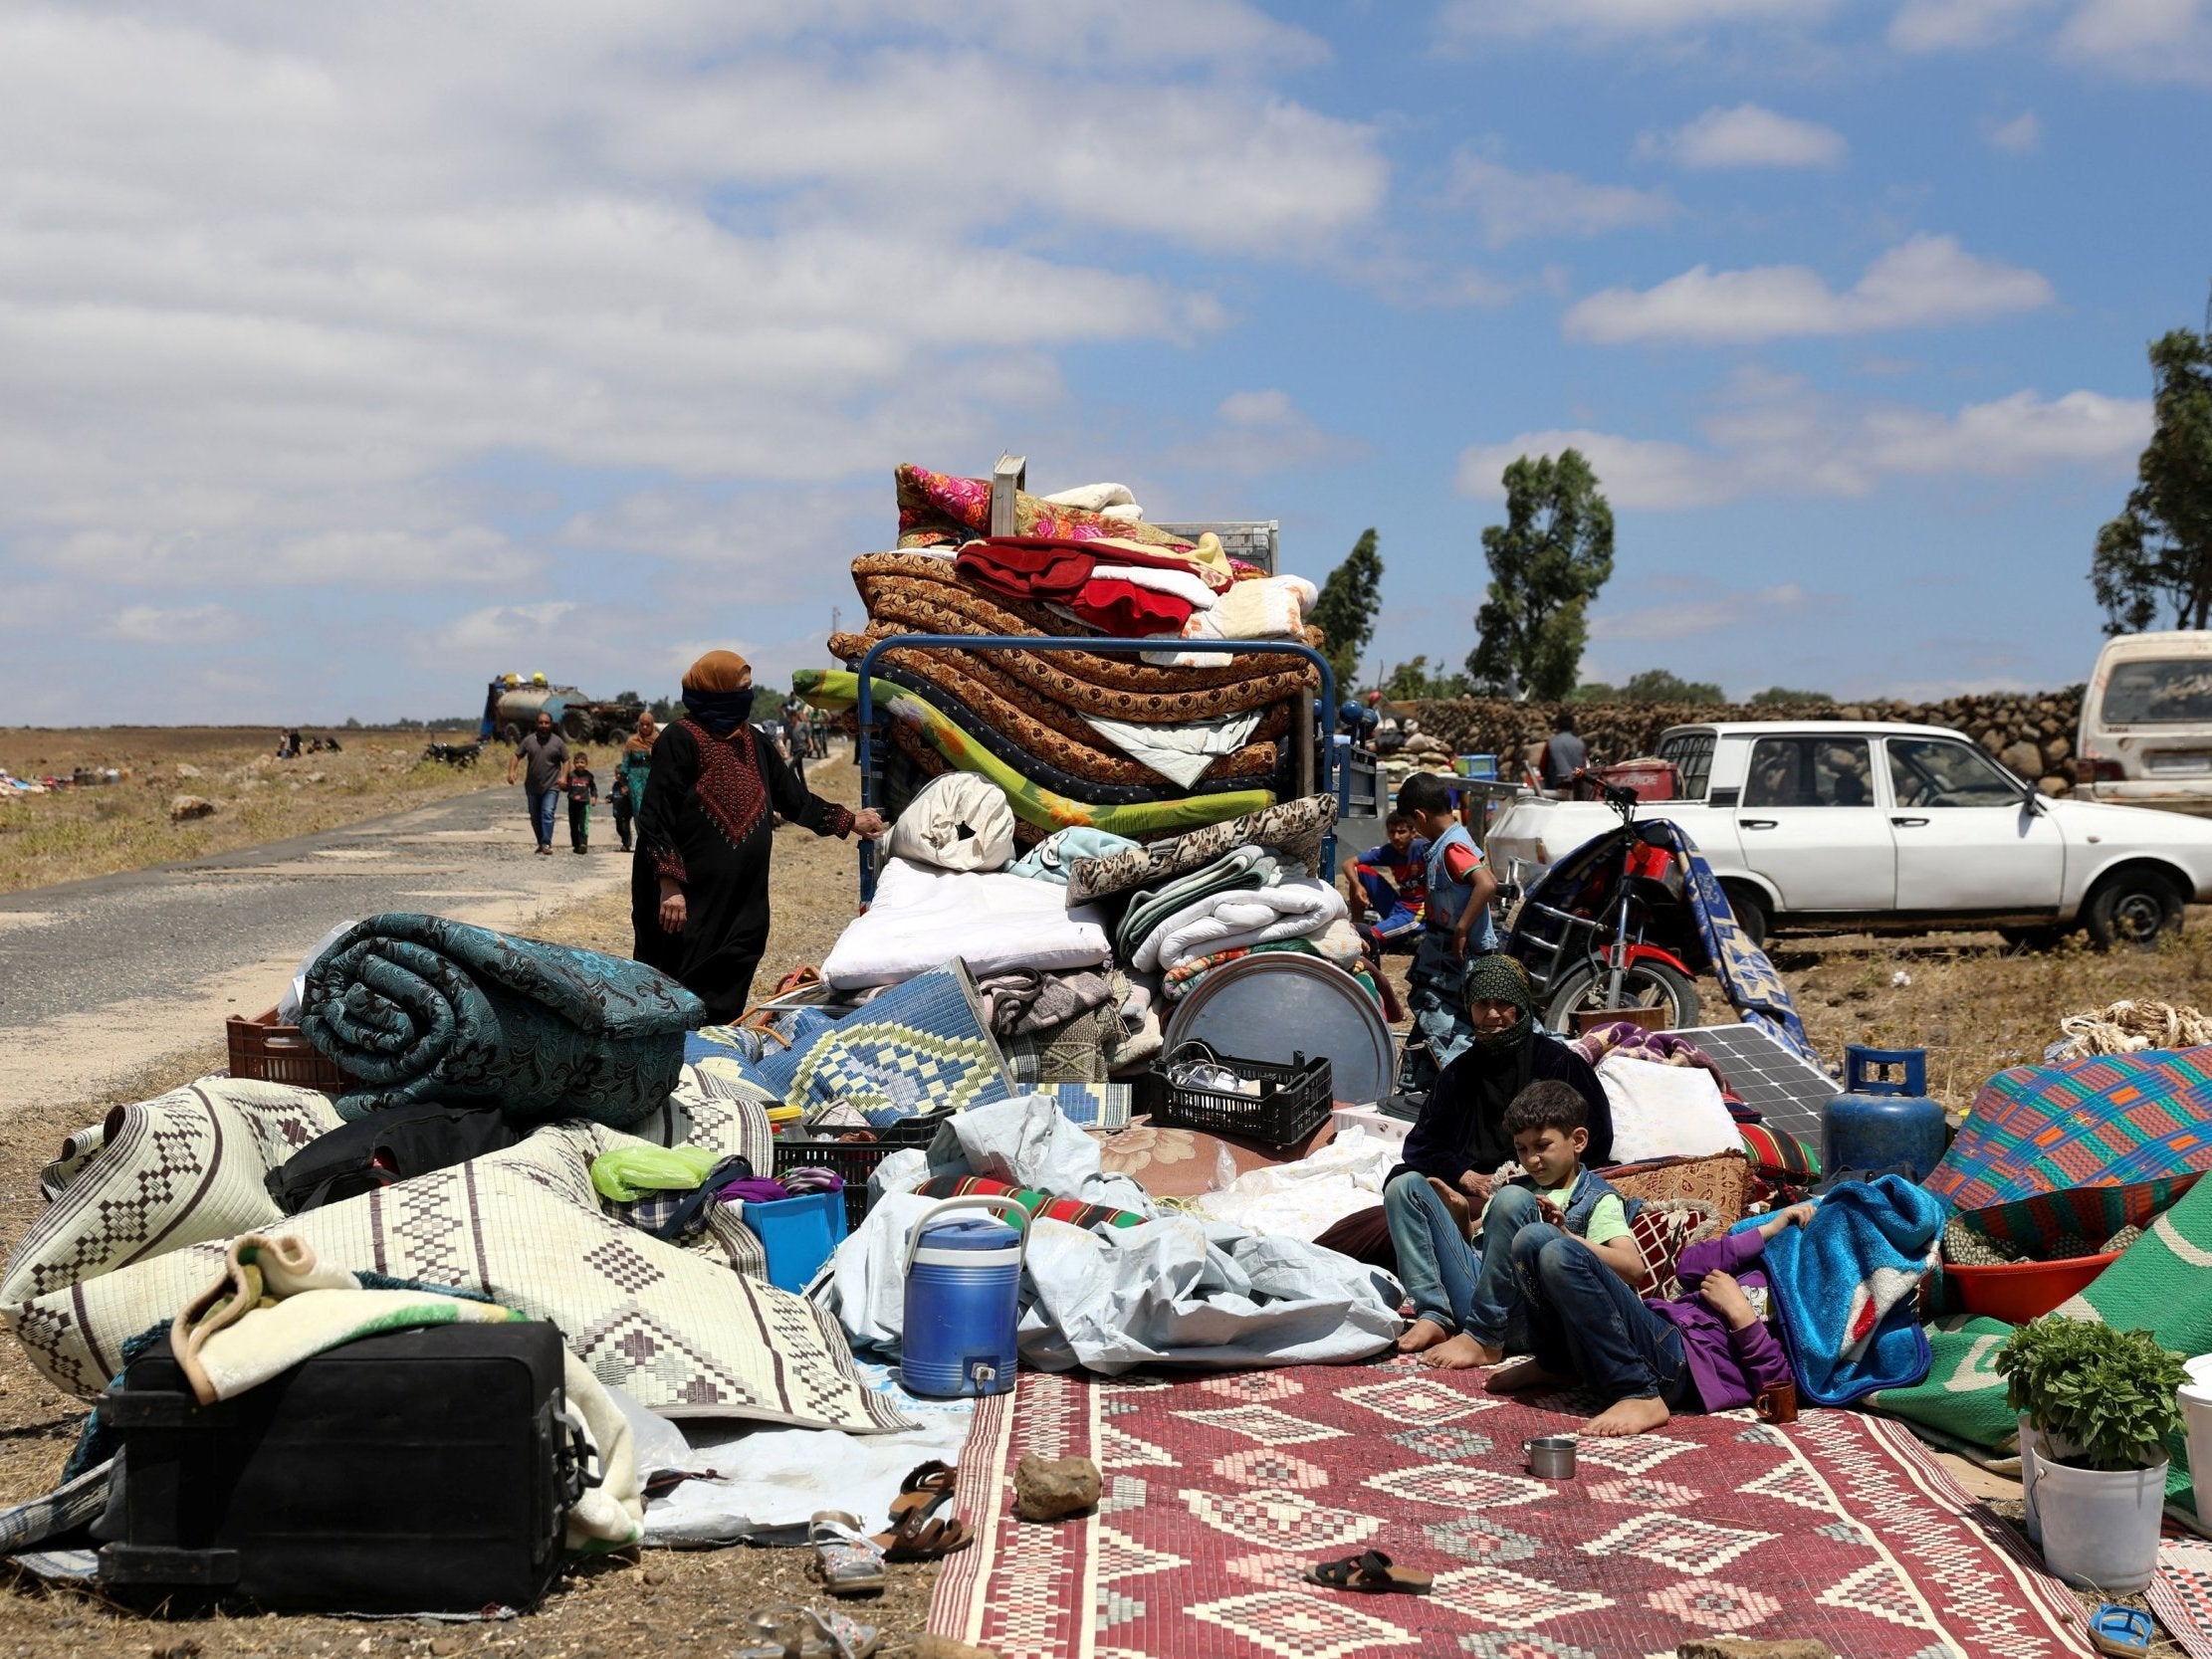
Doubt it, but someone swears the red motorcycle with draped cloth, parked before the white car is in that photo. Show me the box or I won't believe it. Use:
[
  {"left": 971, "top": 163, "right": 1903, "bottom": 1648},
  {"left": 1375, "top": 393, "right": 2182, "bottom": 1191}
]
[{"left": 1504, "top": 783, "right": 1712, "bottom": 1035}]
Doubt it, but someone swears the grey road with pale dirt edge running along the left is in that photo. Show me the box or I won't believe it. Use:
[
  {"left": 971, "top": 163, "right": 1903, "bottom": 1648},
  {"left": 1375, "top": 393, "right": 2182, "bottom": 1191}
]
[{"left": 0, "top": 789, "right": 630, "bottom": 1119}]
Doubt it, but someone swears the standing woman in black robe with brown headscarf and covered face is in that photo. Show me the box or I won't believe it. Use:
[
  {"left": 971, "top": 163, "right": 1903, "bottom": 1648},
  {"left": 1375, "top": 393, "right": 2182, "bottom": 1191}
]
[{"left": 630, "top": 650, "right": 885, "bottom": 1022}]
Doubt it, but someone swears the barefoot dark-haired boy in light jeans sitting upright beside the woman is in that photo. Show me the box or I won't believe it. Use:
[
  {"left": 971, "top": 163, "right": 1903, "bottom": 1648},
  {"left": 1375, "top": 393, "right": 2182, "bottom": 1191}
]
[{"left": 1383, "top": 1080, "right": 1644, "bottom": 1371}]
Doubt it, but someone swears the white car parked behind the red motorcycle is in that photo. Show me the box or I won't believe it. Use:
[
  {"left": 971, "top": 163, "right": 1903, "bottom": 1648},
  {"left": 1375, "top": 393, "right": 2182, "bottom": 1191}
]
[{"left": 1488, "top": 722, "right": 2212, "bottom": 946}]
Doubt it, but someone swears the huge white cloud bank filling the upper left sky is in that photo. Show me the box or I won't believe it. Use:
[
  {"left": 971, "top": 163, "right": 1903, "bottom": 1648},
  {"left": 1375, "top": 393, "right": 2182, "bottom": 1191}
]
[{"left": 0, "top": 0, "right": 1387, "bottom": 717}]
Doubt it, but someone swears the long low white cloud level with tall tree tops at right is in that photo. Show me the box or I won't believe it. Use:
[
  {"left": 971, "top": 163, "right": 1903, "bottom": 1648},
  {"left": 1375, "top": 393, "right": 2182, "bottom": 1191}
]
[{"left": 1457, "top": 376, "right": 2150, "bottom": 511}]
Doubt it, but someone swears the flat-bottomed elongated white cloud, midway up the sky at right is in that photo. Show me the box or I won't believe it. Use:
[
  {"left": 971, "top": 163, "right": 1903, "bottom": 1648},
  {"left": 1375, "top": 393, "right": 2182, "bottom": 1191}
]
[{"left": 1566, "top": 235, "right": 2055, "bottom": 345}]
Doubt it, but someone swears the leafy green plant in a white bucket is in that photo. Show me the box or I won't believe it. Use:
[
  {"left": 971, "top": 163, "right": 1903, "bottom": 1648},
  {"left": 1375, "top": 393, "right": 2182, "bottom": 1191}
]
[{"left": 1995, "top": 1314, "right": 2185, "bottom": 1592}]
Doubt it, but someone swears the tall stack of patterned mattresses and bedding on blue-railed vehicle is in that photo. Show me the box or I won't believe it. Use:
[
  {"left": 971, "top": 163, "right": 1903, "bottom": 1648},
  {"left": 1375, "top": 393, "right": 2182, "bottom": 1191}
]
[{"left": 813, "top": 467, "right": 1321, "bottom": 841}]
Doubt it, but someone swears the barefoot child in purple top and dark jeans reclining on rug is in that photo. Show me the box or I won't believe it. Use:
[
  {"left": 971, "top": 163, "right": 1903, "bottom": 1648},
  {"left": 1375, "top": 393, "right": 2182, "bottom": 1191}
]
[{"left": 1491, "top": 1203, "right": 1814, "bottom": 1438}]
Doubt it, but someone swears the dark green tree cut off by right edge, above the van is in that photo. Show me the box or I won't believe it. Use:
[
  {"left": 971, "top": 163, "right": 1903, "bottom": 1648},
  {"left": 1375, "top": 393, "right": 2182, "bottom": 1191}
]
[{"left": 2089, "top": 327, "right": 2212, "bottom": 633}]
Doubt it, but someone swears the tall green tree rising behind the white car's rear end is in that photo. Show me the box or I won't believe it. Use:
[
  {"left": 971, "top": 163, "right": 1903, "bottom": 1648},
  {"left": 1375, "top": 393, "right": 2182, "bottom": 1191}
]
[{"left": 1466, "top": 449, "right": 1613, "bottom": 702}]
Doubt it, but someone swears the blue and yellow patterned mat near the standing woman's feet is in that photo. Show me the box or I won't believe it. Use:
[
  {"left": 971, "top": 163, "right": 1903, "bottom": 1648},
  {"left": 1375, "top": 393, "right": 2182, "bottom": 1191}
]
[{"left": 684, "top": 957, "right": 1015, "bottom": 1129}]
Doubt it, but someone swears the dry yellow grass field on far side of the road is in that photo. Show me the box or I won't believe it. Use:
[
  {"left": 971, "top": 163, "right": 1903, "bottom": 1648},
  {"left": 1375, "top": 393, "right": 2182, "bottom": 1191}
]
[{"left": 0, "top": 726, "right": 505, "bottom": 894}]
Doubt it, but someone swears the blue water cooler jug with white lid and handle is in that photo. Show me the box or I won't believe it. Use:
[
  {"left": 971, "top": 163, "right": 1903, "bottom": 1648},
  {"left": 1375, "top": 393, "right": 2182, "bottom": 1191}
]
[{"left": 898, "top": 1196, "right": 1028, "bottom": 1400}]
